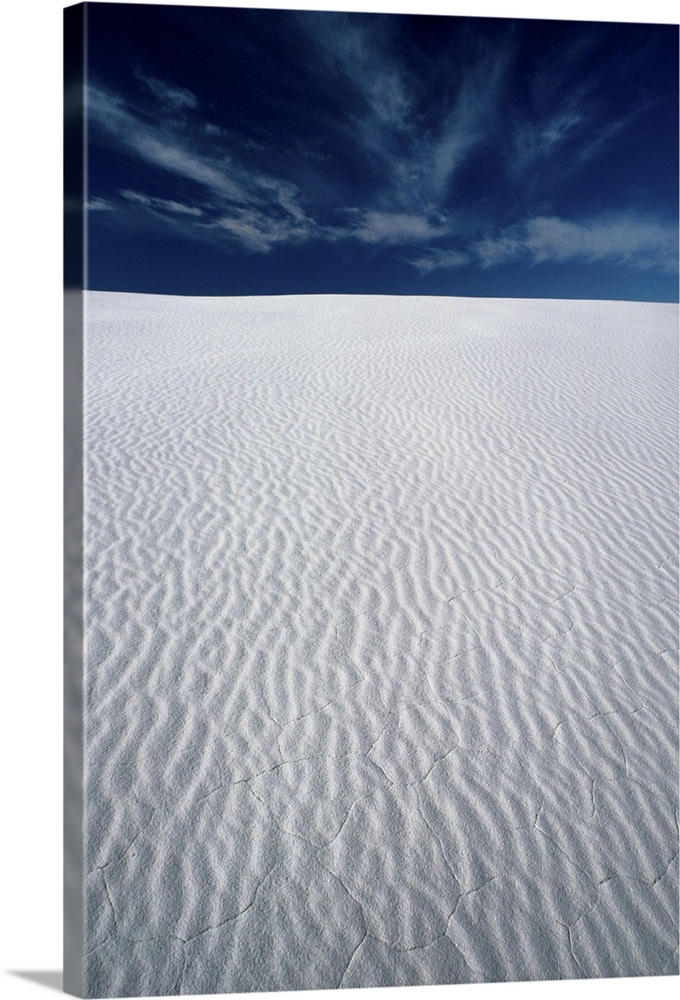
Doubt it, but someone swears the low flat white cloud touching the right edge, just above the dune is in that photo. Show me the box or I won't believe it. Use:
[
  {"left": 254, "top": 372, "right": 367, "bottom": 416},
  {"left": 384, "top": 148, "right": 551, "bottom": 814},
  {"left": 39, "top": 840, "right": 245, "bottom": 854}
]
[{"left": 475, "top": 214, "right": 678, "bottom": 272}]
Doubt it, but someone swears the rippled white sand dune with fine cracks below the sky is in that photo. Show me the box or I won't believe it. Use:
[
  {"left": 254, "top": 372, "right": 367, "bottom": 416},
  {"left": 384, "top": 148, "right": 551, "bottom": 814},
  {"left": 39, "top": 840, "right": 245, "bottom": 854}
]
[{"left": 85, "top": 293, "right": 678, "bottom": 996}]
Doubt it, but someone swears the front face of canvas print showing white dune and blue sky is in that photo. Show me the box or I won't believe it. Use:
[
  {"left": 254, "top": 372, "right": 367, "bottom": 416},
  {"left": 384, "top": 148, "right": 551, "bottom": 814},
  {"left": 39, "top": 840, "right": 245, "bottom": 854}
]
[{"left": 66, "top": 3, "right": 678, "bottom": 997}]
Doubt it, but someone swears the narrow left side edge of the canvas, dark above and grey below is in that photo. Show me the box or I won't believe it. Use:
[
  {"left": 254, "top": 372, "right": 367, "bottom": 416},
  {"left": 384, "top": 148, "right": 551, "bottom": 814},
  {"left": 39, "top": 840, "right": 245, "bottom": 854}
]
[{"left": 64, "top": 4, "right": 85, "bottom": 996}]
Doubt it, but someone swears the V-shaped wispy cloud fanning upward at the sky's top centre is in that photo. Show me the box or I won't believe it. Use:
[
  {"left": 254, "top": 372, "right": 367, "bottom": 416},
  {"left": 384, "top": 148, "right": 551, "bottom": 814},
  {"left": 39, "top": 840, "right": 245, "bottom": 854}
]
[{"left": 300, "top": 14, "right": 515, "bottom": 214}]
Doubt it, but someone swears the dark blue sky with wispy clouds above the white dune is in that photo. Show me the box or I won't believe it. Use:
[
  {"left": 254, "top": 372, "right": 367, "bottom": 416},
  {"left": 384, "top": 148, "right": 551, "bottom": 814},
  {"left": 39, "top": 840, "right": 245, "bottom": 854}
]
[{"left": 87, "top": 4, "right": 678, "bottom": 301}]
